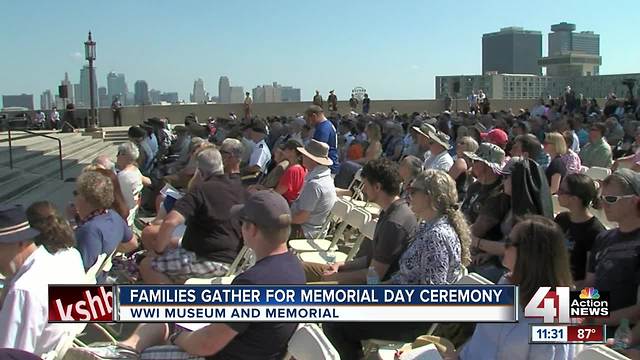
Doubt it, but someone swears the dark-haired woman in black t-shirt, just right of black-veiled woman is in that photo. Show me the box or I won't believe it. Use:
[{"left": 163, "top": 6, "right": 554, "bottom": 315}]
[{"left": 555, "top": 174, "right": 605, "bottom": 282}]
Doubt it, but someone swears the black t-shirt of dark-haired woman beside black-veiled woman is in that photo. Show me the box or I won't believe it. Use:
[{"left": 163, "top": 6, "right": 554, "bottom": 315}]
[{"left": 556, "top": 212, "right": 606, "bottom": 281}]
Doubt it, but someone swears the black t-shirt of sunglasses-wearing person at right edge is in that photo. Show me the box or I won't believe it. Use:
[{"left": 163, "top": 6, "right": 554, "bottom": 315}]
[{"left": 588, "top": 228, "right": 640, "bottom": 311}]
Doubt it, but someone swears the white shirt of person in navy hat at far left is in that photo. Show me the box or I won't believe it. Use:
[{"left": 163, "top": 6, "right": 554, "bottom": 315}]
[{"left": 0, "top": 246, "right": 84, "bottom": 355}]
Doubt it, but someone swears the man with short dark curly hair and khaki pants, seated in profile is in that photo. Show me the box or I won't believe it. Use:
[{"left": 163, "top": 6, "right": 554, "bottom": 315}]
[{"left": 304, "top": 159, "right": 417, "bottom": 284}]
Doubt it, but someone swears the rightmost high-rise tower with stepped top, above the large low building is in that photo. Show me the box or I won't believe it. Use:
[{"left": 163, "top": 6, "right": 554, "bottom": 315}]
[{"left": 538, "top": 22, "right": 602, "bottom": 76}]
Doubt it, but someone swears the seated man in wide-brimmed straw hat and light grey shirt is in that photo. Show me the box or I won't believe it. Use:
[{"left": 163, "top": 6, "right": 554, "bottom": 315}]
[{"left": 291, "top": 139, "right": 337, "bottom": 239}]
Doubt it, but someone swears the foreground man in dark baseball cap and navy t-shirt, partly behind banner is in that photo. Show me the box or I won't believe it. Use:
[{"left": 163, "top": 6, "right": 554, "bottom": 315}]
[{"left": 69, "top": 190, "right": 304, "bottom": 360}]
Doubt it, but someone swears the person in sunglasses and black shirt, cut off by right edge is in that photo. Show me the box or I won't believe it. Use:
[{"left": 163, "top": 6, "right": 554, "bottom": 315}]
[{"left": 576, "top": 169, "right": 640, "bottom": 326}]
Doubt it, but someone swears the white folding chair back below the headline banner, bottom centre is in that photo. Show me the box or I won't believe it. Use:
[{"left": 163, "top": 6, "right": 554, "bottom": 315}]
[{"left": 284, "top": 324, "right": 340, "bottom": 360}]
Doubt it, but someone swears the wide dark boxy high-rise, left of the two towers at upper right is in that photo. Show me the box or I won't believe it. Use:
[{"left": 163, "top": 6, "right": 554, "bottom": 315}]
[{"left": 482, "top": 27, "right": 542, "bottom": 75}]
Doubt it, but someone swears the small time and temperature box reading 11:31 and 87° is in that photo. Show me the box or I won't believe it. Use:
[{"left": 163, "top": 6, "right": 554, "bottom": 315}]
[{"left": 529, "top": 324, "right": 607, "bottom": 344}]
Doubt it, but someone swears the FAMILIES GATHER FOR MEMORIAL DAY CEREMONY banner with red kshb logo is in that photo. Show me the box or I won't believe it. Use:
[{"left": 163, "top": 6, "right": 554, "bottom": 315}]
[{"left": 49, "top": 285, "right": 518, "bottom": 323}]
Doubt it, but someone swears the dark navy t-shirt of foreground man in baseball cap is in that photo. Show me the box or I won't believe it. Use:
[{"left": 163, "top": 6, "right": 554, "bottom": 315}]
[{"left": 208, "top": 252, "right": 306, "bottom": 360}]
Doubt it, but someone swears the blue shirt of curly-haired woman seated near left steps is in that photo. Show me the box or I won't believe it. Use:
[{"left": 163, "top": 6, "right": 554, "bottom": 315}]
[{"left": 75, "top": 210, "right": 133, "bottom": 271}]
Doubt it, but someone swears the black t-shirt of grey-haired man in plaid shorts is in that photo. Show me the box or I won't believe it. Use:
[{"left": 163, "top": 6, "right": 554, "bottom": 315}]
[{"left": 173, "top": 175, "right": 246, "bottom": 264}]
